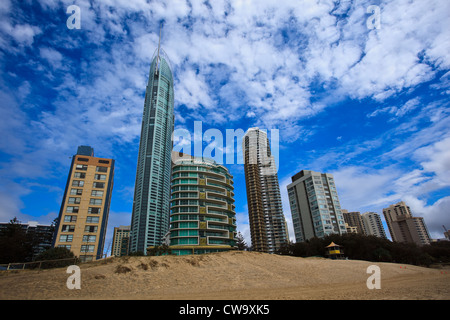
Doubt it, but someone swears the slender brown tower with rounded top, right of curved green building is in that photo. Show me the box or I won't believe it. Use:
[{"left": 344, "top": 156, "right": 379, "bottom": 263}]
[{"left": 242, "top": 128, "right": 289, "bottom": 253}]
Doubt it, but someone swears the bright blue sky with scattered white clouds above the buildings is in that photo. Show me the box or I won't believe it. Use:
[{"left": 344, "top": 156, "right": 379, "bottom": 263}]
[{"left": 0, "top": 0, "right": 450, "bottom": 250}]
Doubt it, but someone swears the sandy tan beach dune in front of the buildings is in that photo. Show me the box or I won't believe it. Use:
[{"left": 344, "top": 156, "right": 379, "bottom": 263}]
[{"left": 0, "top": 251, "right": 450, "bottom": 300}]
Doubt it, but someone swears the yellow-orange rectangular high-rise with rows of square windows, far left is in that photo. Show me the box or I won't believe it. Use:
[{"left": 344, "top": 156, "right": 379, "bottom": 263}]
[{"left": 53, "top": 146, "right": 114, "bottom": 261}]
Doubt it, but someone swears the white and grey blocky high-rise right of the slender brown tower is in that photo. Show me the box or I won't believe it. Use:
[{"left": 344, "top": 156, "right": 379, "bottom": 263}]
[{"left": 287, "top": 170, "right": 347, "bottom": 242}]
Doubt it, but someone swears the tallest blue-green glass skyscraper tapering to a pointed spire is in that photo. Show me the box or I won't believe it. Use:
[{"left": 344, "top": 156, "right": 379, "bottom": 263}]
[{"left": 130, "top": 30, "right": 174, "bottom": 253}]
